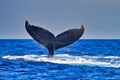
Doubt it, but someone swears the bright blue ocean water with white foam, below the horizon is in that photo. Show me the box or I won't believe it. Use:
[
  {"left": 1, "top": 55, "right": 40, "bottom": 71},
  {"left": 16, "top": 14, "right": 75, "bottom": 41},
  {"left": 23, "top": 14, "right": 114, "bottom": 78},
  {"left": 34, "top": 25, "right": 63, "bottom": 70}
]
[{"left": 0, "top": 39, "right": 120, "bottom": 80}]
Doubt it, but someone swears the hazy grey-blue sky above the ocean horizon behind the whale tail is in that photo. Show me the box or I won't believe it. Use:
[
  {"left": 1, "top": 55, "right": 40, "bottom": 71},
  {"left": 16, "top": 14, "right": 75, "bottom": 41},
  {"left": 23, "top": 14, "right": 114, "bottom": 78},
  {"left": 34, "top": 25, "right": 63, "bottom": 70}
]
[{"left": 0, "top": 0, "right": 120, "bottom": 39}]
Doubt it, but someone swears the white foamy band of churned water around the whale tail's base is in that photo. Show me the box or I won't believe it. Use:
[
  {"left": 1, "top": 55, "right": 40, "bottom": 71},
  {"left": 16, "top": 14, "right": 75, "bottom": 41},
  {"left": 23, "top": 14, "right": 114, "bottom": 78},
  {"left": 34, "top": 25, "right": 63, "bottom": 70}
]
[{"left": 2, "top": 54, "right": 120, "bottom": 68}]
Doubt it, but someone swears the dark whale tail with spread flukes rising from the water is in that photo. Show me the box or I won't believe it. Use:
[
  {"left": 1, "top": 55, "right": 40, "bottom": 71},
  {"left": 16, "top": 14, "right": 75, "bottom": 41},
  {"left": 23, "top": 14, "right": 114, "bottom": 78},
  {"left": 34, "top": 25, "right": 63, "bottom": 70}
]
[{"left": 25, "top": 21, "right": 84, "bottom": 57}]
